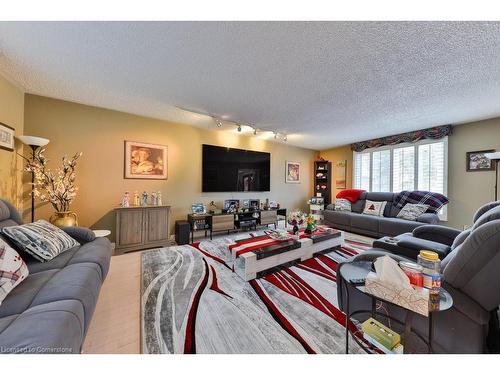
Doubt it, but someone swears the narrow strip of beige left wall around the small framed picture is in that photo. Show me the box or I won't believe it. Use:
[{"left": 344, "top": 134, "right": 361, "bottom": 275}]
[{"left": 0, "top": 75, "right": 24, "bottom": 210}]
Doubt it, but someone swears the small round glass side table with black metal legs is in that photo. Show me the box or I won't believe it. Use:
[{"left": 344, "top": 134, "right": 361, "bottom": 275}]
[{"left": 340, "top": 261, "right": 453, "bottom": 354}]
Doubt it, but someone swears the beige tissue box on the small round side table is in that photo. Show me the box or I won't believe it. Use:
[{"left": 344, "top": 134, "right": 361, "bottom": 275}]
[{"left": 365, "top": 272, "right": 429, "bottom": 316}]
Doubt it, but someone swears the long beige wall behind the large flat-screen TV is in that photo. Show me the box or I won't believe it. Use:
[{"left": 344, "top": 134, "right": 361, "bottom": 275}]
[{"left": 25, "top": 95, "right": 316, "bottom": 241}]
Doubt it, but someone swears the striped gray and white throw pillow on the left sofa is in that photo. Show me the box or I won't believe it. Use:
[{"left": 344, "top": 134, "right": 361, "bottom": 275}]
[{"left": 2, "top": 220, "right": 79, "bottom": 262}]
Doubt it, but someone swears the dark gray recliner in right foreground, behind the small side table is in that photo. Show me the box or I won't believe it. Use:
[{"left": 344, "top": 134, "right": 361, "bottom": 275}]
[{"left": 337, "top": 202, "right": 500, "bottom": 353}]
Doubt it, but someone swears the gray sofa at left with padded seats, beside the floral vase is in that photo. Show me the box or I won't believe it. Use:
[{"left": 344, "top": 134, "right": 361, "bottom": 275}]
[{"left": 0, "top": 200, "right": 112, "bottom": 353}]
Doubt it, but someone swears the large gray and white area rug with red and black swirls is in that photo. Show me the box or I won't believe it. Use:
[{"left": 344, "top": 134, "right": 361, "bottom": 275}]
[{"left": 141, "top": 232, "right": 373, "bottom": 354}]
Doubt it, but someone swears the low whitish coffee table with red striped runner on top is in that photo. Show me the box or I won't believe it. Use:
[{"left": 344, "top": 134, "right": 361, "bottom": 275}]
[{"left": 226, "top": 229, "right": 345, "bottom": 281}]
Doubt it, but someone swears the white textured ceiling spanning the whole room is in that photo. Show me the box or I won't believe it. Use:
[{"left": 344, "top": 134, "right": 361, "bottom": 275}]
[{"left": 0, "top": 22, "right": 500, "bottom": 149}]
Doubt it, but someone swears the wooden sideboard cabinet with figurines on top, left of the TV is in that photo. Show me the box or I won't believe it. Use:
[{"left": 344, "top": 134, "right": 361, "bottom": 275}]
[{"left": 115, "top": 206, "right": 172, "bottom": 254}]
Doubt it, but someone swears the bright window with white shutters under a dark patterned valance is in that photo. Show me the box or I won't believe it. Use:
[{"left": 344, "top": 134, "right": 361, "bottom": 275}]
[{"left": 353, "top": 137, "right": 448, "bottom": 220}]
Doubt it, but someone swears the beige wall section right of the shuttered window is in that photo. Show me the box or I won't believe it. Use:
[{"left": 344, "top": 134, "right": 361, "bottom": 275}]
[{"left": 447, "top": 118, "right": 500, "bottom": 229}]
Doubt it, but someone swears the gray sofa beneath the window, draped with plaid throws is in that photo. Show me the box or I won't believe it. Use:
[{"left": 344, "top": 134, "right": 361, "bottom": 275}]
[{"left": 324, "top": 192, "right": 439, "bottom": 238}]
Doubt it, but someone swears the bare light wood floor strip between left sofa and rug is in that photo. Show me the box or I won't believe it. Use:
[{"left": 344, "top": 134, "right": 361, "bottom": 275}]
[{"left": 83, "top": 251, "right": 141, "bottom": 354}]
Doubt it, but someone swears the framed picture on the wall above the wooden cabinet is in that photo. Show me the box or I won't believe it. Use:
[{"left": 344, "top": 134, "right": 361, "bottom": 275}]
[{"left": 125, "top": 141, "right": 167, "bottom": 180}]
